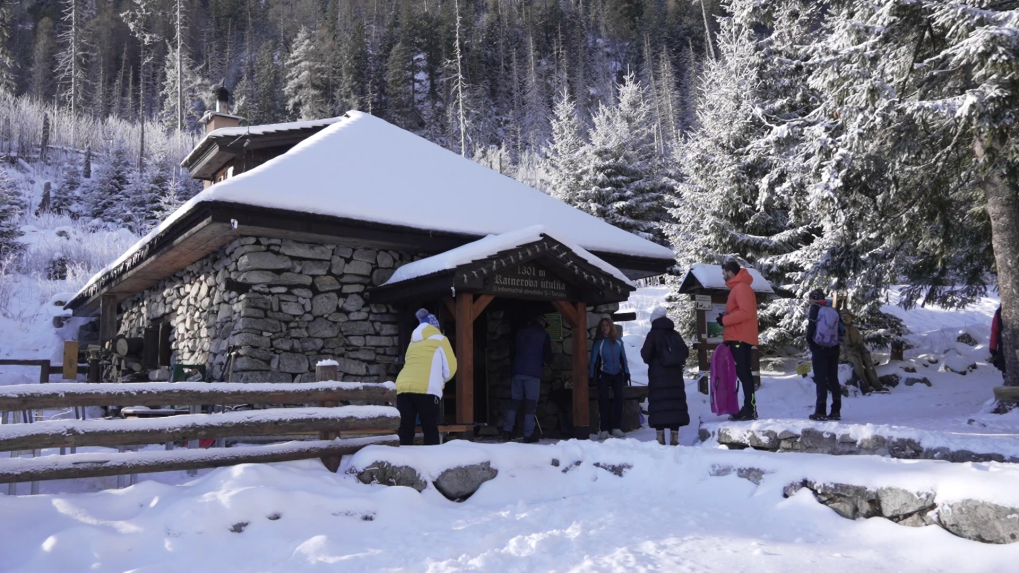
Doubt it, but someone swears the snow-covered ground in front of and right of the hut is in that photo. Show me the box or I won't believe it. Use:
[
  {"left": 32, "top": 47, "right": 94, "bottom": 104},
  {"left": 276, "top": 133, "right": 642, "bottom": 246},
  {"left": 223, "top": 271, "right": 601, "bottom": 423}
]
[{"left": 0, "top": 288, "right": 1019, "bottom": 573}]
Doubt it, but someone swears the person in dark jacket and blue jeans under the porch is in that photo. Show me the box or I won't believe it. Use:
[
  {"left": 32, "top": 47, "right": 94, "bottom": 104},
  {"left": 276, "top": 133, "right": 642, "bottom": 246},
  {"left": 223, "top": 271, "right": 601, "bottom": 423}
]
[{"left": 502, "top": 317, "right": 552, "bottom": 444}]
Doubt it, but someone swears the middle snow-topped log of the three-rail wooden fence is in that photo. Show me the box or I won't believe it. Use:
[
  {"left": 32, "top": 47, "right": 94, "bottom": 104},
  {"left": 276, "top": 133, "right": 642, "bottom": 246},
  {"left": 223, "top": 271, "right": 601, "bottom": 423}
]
[{"left": 0, "top": 406, "right": 399, "bottom": 452}]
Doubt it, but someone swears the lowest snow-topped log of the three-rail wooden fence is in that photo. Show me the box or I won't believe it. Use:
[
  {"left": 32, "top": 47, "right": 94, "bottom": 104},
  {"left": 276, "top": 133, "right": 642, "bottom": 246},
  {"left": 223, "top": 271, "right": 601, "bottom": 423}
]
[{"left": 0, "top": 435, "right": 399, "bottom": 483}]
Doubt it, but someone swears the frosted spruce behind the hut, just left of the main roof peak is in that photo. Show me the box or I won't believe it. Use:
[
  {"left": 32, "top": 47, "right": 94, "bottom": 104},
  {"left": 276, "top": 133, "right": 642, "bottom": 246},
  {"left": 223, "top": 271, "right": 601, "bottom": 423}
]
[{"left": 283, "top": 28, "right": 329, "bottom": 121}]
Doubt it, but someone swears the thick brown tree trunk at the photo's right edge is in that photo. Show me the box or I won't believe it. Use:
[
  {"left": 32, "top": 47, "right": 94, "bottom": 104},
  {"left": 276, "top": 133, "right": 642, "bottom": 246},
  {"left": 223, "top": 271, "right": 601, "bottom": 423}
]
[{"left": 975, "top": 142, "right": 1019, "bottom": 386}]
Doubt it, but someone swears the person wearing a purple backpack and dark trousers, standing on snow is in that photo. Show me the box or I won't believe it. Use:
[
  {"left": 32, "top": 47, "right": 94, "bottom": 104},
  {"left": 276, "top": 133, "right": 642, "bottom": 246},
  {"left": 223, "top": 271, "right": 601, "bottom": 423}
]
[{"left": 807, "top": 289, "right": 842, "bottom": 421}]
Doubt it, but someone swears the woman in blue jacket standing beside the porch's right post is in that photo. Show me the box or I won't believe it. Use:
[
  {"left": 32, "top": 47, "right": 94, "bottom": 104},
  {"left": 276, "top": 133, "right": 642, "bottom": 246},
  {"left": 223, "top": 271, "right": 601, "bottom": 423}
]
[{"left": 588, "top": 317, "right": 630, "bottom": 439}]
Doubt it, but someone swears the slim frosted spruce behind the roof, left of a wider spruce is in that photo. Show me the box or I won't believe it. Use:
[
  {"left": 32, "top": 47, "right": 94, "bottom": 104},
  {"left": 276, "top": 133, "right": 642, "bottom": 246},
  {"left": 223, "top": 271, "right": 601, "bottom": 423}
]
[{"left": 543, "top": 91, "right": 585, "bottom": 203}]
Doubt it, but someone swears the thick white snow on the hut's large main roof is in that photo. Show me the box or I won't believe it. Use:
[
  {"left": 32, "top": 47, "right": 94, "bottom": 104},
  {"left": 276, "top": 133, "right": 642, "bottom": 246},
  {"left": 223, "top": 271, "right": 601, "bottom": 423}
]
[{"left": 77, "top": 111, "right": 673, "bottom": 303}]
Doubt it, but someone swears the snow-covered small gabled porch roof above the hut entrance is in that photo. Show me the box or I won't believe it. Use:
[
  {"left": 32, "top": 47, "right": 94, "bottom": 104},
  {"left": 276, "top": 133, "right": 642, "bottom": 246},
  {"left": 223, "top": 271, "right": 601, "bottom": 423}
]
[{"left": 385, "top": 225, "right": 633, "bottom": 285}]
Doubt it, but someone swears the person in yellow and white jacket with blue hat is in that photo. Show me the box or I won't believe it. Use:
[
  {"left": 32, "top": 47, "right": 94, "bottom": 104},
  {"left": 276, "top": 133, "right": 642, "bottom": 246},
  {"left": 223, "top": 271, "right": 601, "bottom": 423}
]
[{"left": 396, "top": 309, "right": 457, "bottom": 446}]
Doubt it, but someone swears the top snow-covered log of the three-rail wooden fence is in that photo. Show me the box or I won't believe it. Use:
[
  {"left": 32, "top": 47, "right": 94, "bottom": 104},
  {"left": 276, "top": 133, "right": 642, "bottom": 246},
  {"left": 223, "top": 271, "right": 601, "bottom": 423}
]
[{"left": 0, "top": 379, "right": 396, "bottom": 412}]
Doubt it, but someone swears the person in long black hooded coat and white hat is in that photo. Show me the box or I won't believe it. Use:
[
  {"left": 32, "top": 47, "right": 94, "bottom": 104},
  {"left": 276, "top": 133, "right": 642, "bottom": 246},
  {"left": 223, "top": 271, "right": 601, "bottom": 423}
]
[{"left": 640, "top": 307, "right": 690, "bottom": 446}]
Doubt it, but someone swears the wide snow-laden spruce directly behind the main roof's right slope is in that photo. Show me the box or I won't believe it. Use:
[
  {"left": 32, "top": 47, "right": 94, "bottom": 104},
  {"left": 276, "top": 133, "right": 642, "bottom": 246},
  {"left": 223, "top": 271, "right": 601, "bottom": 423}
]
[{"left": 572, "top": 73, "right": 673, "bottom": 244}]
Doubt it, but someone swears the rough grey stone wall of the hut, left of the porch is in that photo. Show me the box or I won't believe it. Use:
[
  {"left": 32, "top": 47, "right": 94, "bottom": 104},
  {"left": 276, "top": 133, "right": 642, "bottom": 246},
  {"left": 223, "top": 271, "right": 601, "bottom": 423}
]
[{"left": 120, "top": 237, "right": 413, "bottom": 382}]
